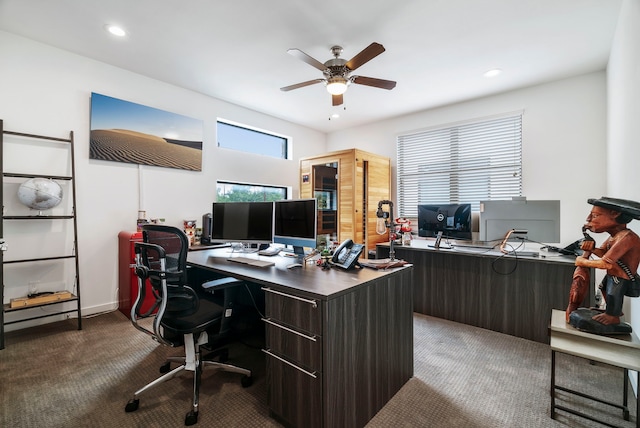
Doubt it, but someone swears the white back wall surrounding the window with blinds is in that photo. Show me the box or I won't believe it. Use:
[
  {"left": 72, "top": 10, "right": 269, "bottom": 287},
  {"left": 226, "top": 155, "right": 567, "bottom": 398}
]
[{"left": 327, "top": 71, "right": 607, "bottom": 246}]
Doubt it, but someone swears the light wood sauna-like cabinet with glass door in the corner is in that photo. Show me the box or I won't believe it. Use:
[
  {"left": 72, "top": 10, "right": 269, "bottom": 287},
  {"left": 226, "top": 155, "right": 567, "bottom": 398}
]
[{"left": 300, "top": 149, "right": 391, "bottom": 256}]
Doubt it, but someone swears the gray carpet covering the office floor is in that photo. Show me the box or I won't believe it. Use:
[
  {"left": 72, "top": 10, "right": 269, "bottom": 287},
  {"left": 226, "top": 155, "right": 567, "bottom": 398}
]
[{"left": 0, "top": 312, "right": 636, "bottom": 428}]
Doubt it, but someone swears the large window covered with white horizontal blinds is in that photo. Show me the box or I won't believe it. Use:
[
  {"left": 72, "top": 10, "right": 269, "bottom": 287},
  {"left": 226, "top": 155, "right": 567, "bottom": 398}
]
[{"left": 397, "top": 113, "right": 522, "bottom": 218}]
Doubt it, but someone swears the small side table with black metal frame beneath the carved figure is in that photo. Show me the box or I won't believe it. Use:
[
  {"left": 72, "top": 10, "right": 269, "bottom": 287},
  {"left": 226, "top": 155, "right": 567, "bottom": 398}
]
[{"left": 549, "top": 309, "right": 640, "bottom": 428}]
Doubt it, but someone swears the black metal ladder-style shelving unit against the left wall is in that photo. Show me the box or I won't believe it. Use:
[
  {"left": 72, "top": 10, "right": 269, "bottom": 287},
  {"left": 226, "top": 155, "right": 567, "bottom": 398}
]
[{"left": 0, "top": 120, "right": 82, "bottom": 349}]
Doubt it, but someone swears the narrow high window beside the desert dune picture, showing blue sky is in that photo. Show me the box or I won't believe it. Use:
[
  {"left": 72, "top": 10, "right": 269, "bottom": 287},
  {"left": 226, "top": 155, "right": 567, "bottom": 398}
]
[{"left": 216, "top": 119, "right": 289, "bottom": 159}]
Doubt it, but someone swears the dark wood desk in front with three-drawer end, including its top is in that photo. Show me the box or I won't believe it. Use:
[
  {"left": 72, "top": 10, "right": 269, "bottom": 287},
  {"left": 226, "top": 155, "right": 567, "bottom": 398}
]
[{"left": 188, "top": 248, "right": 413, "bottom": 427}]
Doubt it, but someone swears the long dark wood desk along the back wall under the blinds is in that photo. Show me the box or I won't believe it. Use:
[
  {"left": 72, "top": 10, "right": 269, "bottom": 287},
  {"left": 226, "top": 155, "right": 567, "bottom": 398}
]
[{"left": 376, "top": 240, "right": 594, "bottom": 343}]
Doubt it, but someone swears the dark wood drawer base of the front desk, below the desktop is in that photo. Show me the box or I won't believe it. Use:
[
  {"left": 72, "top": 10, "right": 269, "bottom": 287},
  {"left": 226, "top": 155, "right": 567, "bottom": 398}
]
[{"left": 265, "top": 268, "right": 413, "bottom": 428}]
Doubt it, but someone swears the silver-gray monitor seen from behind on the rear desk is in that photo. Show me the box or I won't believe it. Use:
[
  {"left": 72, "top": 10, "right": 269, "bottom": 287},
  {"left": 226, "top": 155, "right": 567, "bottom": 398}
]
[{"left": 478, "top": 199, "right": 560, "bottom": 243}]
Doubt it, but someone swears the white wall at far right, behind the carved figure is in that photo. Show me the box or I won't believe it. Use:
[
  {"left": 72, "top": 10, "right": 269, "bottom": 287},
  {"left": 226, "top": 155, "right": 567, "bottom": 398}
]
[{"left": 607, "top": 0, "right": 640, "bottom": 350}]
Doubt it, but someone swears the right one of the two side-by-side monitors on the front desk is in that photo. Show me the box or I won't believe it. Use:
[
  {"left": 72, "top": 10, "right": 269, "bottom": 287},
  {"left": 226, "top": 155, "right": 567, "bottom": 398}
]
[{"left": 273, "top": 199, "right": 318, "bottom": 255}]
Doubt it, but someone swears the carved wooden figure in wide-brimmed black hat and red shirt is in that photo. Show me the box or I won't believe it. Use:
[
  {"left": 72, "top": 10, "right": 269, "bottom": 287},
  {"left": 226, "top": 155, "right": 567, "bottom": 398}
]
[{"left": 566, "top": 196, "right": 640, "bottom": 334}]
